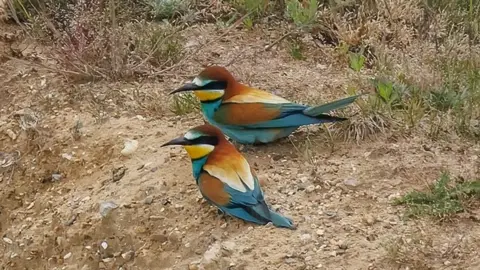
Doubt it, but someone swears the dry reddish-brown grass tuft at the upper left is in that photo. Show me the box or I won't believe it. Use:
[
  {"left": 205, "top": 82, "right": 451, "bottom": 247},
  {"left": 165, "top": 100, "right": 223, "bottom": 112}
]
[{"left": 7, "top": 0, "right": 188, "bottom": 81}]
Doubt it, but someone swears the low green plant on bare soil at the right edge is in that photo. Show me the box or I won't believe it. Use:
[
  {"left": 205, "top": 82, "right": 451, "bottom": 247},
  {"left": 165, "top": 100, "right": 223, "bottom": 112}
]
[{"left": 394, "top": 172, "right": 480, "bottom": 218}]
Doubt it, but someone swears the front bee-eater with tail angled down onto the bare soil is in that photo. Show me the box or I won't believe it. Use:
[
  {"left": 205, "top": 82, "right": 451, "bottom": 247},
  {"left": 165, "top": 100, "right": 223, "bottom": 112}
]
[{"left": 161, "top": 123, "right": 296, "bottom": 229}]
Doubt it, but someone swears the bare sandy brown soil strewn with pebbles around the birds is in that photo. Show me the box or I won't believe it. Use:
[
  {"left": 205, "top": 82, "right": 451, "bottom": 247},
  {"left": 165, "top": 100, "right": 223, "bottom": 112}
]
[{"left": 0, "top": 21, "right": 480, "bottom": 270}]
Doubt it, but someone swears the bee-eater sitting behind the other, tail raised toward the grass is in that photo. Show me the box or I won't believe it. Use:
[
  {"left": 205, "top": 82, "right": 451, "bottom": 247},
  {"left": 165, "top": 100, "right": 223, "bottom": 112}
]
[{"left": 169, "top": 66, "right": 362, "bottom": 144}]
